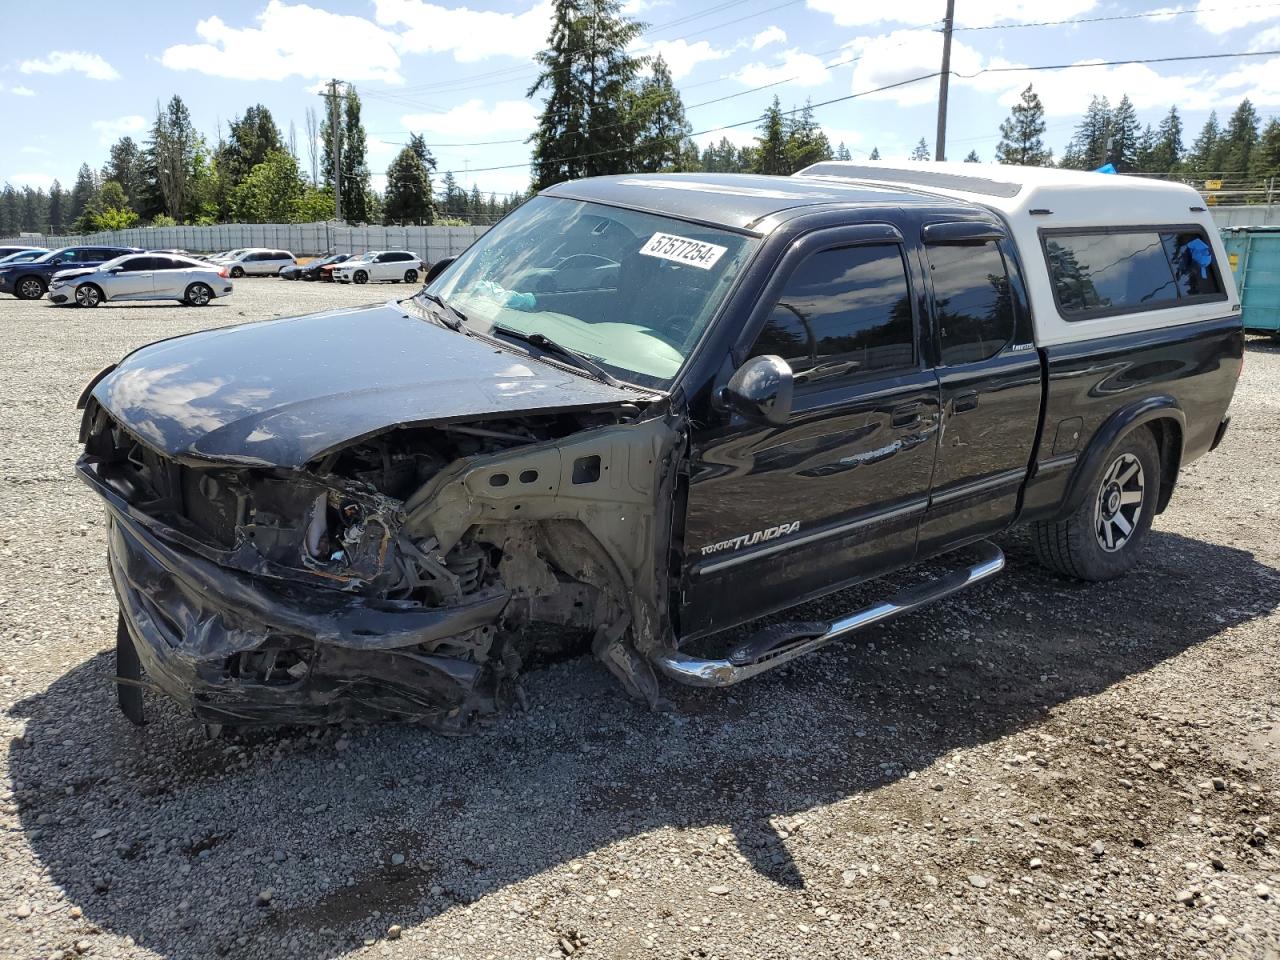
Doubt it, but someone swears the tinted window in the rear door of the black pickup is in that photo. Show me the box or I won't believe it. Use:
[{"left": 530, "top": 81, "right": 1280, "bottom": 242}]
[{"left": 927, "top": 241, "right": 1014, "bottom": 366}]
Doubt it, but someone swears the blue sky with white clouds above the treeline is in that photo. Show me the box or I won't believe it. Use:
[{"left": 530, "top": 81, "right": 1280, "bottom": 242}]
[{"left": 0, "top": 0, "right": 1280, "bottom": 199}]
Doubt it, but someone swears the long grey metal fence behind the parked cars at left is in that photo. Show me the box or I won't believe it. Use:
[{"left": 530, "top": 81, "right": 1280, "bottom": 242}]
[{"left": 0, "top": 223, "right": 489, "bottom": 264}]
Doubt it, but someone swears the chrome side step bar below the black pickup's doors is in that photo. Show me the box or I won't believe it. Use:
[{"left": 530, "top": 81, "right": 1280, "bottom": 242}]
[{"left": 654, "top": 540, "right": 1005, "bottom": 686}]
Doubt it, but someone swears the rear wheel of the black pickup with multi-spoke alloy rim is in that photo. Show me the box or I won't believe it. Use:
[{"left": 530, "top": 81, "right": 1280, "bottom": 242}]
[{"left": 1033, "top": 428, "right": 1161, "bottom": 581}]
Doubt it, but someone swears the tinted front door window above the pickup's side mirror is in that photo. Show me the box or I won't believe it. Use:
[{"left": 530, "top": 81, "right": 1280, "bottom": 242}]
[{"left": 751, "top": 244, "right": 915, "bottom": 383}]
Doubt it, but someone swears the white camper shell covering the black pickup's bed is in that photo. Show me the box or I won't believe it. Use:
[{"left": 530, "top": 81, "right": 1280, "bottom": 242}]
[{"left": 796, "top": 161, "right": 1240, "bottom": 347}]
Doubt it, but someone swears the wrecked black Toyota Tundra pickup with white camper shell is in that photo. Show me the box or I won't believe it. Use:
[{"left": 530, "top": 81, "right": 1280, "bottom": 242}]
[{"left": 78, "top": 164, "right": 1243, "bottom": 728}]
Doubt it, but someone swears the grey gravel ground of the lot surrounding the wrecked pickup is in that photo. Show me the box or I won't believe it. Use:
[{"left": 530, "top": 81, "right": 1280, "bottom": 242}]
[{"left": 0, "top": 280, "right": 1280, "bottom": 960}]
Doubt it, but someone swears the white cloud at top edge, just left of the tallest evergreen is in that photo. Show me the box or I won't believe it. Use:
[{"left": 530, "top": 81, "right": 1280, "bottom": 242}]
[{"left": 374, "top": 0, "right": 552, "bottom": 63}]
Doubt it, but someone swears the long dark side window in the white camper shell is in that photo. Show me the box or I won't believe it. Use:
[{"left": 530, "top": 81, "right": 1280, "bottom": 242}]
[{"left": 1044, "top": 229, "right": 1225, "bottom": 320}]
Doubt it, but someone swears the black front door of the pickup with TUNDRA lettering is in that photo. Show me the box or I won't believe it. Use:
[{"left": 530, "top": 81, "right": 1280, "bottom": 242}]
[{"left": 680, "top": 225, "right": 938, "bottom": 637}]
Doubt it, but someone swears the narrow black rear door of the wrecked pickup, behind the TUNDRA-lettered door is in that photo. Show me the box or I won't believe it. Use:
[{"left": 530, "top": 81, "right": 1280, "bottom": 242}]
[{"left": 920, "top": 221, "right": 1041, "bottom": 557}]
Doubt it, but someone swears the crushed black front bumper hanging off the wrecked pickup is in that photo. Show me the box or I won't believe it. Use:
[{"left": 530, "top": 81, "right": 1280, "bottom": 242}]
[{"left": 79, "top": 463, "right": 508, "bottom": 728}]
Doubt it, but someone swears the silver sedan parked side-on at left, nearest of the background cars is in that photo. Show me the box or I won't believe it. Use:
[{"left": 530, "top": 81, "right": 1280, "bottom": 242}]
[{"left": 49, "top": 252, "right": 232, "bottom": 307}]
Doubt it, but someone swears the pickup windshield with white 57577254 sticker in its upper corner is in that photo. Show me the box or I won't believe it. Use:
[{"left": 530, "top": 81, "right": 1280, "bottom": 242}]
[{"left": 428, "top": 197, "right": 756, "bottom": 387}]
